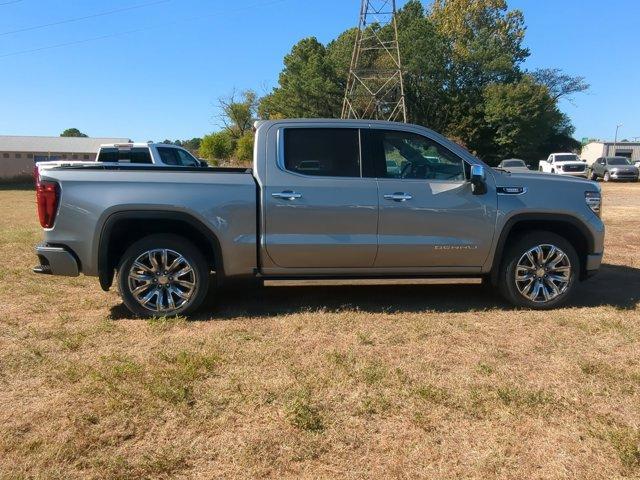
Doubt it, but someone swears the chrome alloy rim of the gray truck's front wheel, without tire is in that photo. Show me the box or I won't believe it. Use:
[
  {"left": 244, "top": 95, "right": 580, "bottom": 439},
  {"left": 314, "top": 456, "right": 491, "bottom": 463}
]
[{"left": 515, "top": 244, "right": 571, "bottom": 303}]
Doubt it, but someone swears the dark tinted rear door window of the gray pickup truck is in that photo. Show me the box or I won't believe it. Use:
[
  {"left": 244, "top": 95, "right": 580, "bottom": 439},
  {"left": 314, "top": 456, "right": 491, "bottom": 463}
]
[{"left": 284, "top": 128, "right": 361, "bottom": 177}]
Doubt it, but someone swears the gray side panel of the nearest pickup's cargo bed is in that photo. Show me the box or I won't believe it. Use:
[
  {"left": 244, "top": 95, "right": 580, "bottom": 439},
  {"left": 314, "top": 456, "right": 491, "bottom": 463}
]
[{"left": 40, "top": 163, "right": 258, "bottom": 275}]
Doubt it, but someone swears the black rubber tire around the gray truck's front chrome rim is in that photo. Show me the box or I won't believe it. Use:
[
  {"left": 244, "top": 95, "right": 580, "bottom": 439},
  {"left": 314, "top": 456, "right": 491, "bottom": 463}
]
[{"left": 498, "top": 231, "right": 580, "bottom": 310}]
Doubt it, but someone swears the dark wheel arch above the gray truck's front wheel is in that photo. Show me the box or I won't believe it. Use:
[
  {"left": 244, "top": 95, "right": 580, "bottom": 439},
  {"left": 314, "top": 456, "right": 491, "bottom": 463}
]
[{"left": 490, "top": 213, "right": 595, "bottom": 285}]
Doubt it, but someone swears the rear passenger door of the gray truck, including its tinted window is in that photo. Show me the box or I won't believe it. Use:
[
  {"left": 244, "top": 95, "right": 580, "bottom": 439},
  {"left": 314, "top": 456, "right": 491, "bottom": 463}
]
[{"left": 262, "top": 127, "right": 378, "bottom": 269}]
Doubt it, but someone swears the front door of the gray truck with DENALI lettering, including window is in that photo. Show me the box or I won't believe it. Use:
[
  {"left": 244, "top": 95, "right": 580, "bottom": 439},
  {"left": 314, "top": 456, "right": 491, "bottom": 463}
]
[{"left": 363, "top": 130, "right": 497, "bottom": 268}]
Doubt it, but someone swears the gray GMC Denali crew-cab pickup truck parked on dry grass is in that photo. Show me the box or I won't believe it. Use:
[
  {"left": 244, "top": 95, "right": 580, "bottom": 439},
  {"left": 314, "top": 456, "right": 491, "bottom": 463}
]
[{"left": 34, "top": 120, "right": 604, "bottom": 316}]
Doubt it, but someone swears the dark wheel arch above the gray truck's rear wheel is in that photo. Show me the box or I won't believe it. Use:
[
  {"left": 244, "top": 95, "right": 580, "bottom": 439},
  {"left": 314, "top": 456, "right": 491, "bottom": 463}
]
[{"left": 97, "top": 210, "right": 224, "bottom": 291}]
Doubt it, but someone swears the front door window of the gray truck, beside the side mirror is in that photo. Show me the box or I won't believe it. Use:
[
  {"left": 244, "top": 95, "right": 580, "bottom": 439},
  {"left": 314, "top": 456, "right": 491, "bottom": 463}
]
[{"left": 382, "top": 130, "right": 465, "bottom": 180}]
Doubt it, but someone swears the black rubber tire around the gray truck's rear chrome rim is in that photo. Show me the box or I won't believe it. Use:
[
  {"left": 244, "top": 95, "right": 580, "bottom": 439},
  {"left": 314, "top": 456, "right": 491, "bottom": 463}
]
[{"left": 118, "top": 234, "right": 210, "bottom": 317}]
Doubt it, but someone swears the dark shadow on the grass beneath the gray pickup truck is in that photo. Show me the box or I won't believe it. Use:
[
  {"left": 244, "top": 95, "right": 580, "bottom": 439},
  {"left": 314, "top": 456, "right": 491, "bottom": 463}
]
[{"left": 111, "top": 264, "right": 640, "bottom": 321}]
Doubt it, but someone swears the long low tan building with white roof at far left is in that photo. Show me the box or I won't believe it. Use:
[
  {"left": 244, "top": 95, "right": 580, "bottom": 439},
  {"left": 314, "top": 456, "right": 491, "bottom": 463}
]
[{"left": 0, "top": 135, "right": 129, "bottom": 179}]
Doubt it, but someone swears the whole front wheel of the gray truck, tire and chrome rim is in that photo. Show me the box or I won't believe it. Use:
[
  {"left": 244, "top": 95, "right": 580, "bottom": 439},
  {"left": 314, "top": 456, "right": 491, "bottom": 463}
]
[{"left": 498, "top": 231, "right": 580, "bottom": 310}]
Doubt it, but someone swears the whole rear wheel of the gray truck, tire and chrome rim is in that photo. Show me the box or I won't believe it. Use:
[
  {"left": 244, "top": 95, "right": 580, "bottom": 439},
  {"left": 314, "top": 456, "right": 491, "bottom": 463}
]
[{"left": 118, "top": 234, "right": 209, "bottom": 317}]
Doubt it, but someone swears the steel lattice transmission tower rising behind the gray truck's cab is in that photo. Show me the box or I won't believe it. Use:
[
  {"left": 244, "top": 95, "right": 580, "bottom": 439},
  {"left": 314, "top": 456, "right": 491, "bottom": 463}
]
[{"left": 342, "top": 0, "right": 407, "bottom": 122}]
